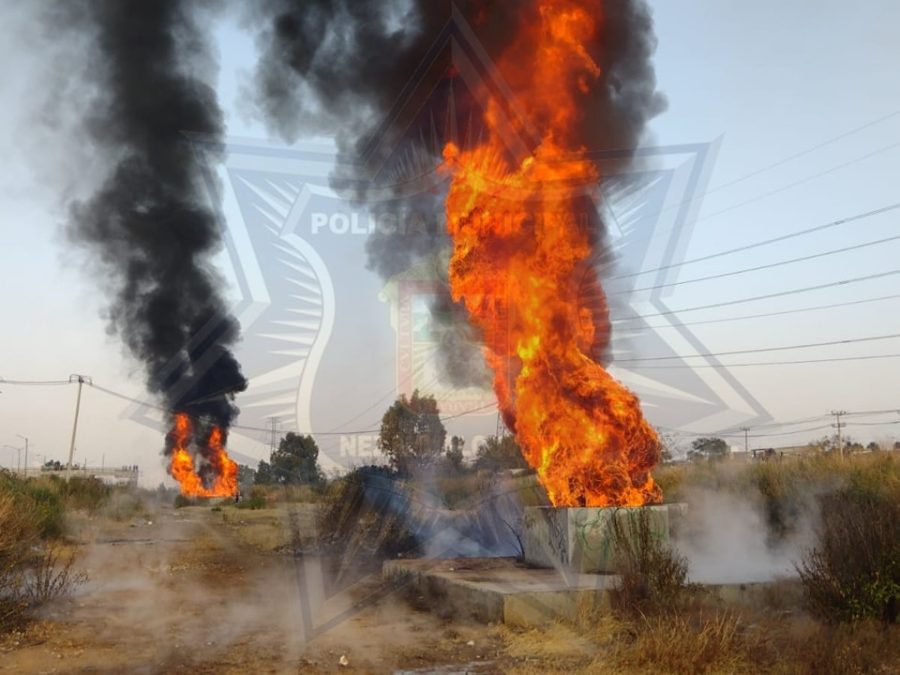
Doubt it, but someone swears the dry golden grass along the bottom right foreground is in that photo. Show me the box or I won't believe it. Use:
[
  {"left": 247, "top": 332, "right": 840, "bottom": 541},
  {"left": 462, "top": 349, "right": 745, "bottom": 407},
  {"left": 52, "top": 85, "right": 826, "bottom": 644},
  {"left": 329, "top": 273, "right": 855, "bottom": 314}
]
[{"left": 501, "top": 608, "right": 900, "bottom": 675}]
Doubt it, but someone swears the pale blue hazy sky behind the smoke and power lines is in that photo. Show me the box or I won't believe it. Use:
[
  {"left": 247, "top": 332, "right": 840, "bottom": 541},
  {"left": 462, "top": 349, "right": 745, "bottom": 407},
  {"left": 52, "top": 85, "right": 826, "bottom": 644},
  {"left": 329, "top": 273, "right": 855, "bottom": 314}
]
[{"left": 0, "top": 0, "right": 900, "bottom": 486}]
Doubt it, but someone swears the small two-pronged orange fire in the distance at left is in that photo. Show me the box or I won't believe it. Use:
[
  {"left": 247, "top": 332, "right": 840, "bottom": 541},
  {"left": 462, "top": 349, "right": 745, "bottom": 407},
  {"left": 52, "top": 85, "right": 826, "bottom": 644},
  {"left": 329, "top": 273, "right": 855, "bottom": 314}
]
[{"left": 169, "top": 413, "right": 238, "bottom": 498}]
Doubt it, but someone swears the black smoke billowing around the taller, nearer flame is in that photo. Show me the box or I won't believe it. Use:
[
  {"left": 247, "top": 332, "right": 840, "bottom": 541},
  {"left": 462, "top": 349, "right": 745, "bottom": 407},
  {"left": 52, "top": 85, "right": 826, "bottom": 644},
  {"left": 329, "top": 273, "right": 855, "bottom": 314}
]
[{"left": 246, "top": 0, "right": 665, "bottom": 385}]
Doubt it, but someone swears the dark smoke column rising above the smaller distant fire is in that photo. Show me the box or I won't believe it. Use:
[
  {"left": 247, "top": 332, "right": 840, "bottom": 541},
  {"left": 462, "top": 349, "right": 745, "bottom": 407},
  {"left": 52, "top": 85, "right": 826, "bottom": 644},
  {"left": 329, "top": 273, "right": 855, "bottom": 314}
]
[{"left": 57, "top": 0, "right": 247, "bottom": 438}]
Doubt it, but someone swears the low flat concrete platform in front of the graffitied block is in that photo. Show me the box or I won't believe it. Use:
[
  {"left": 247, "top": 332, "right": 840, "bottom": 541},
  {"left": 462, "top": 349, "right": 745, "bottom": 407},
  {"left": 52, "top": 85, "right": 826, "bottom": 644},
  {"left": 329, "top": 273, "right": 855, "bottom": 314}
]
[{"left": 382, "top": 558, "right": 619, "bottom": 626}]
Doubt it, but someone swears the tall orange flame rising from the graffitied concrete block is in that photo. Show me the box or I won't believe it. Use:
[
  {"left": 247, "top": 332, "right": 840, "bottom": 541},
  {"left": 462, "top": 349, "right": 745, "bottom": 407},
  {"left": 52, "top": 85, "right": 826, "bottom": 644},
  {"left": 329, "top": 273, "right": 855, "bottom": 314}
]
[{"left": 443, "top": 0, "right": 662, "bottom": 506}]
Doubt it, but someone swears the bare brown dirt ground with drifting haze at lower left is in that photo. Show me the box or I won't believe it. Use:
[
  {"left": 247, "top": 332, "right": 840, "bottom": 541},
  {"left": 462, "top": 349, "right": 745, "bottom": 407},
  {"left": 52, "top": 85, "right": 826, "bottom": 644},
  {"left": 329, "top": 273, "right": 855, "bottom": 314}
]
[{"left": 0, "top": 504, "right": 540, "bottom": 673}]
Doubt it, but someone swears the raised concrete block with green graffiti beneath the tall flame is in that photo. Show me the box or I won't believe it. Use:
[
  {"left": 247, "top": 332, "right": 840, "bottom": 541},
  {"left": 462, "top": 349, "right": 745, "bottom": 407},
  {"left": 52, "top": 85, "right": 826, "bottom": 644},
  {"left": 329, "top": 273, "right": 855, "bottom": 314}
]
[{"left": 522, "top": 504, "right": 680, "bottom": 574}]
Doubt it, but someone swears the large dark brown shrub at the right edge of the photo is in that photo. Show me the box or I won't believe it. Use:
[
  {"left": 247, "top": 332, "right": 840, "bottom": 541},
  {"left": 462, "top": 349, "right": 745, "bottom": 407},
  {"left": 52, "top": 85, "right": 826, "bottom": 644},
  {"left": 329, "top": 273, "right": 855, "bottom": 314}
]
[{"left": 798, "top": 490, "right": 900, "bottom": 623}]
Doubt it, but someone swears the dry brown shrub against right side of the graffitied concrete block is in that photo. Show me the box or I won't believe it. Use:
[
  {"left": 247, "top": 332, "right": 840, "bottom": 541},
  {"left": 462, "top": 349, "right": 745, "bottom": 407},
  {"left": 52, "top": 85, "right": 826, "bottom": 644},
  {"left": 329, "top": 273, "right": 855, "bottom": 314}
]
[{"left": 610, "top": 509, "right": 691, "bottom": 614}]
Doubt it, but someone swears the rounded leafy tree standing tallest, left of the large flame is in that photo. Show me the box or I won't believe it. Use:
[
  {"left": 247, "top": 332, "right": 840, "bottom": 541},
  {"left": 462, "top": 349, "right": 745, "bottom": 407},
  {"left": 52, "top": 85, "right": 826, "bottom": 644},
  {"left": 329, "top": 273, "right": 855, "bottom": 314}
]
[{"left": 378, "top": 390, "right": 447, "bottom": 475}]
